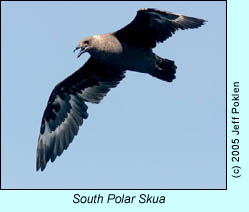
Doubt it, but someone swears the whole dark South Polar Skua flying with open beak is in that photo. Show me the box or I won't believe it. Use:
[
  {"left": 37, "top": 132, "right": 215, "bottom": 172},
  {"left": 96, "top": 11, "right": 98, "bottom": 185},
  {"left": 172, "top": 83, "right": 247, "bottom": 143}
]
[{"left": 36, "top": 8, "right": 206, "bottom": 171}]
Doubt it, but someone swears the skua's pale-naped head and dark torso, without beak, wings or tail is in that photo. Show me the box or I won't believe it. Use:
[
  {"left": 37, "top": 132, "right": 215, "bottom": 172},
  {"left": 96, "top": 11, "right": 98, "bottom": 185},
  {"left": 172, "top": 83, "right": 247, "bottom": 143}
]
[{"left": 80, "top": 33, "right": 155, "bottom": 73}]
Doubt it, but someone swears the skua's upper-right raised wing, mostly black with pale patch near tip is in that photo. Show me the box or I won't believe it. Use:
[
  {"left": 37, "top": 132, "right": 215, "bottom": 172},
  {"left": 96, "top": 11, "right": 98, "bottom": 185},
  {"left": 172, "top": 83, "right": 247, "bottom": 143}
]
[{"left": 114, "top": 8, "right": 206, "bottom": 48}]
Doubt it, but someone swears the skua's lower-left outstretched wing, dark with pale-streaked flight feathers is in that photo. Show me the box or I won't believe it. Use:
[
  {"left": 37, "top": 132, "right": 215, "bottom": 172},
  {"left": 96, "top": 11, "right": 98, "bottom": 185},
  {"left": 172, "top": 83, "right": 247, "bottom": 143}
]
[{"left": 36, "top": 58, "right": 124, "bottom": 171}]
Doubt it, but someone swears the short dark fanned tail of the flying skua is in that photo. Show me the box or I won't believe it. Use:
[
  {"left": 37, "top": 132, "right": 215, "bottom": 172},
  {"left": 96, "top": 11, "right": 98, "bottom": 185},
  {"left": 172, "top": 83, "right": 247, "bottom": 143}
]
[{"left": 151, "top": 55, "right": 177, "bottom": 82}]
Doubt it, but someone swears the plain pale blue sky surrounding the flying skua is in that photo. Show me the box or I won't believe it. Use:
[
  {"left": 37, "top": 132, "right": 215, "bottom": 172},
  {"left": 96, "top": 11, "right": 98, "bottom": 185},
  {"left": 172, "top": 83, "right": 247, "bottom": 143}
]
[{"left": 1, "top": 2, "right": 226, "bottom": 189}]
